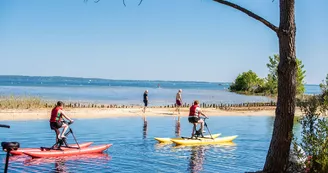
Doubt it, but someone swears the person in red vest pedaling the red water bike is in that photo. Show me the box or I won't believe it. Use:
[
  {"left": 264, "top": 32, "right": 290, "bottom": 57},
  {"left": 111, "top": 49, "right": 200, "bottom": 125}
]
[{"left": 49, "top": 101, "right": 74, "bottom": 142}]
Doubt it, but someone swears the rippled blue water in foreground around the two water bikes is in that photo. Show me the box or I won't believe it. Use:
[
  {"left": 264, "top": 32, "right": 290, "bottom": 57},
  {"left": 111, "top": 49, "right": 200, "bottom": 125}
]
[{"left": 0, "top": 116, "right": 300, "bottom": 173}]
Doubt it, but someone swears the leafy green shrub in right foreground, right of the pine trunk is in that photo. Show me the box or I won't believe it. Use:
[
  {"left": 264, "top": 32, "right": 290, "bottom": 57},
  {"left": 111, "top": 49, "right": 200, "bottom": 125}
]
[{"left": 294, "top": 75, "right": 328, "bottom": 173}]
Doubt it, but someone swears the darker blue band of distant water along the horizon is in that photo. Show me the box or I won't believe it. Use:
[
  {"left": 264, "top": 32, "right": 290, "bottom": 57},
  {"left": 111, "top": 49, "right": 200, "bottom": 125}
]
[{"left": 0, "top": 75, "right": 231, "bottom": 89}]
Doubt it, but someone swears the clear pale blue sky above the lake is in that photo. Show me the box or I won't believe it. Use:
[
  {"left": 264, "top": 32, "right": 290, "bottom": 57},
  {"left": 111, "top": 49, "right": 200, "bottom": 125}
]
[{"left": 0, "top": 0, "right": 328, "bottom": 84}]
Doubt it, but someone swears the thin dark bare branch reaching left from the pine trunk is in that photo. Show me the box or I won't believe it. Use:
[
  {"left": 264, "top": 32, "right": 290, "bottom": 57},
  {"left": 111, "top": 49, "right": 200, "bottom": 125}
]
[{"left": 213, "top": 0, "right": 279, "bottom": 33}]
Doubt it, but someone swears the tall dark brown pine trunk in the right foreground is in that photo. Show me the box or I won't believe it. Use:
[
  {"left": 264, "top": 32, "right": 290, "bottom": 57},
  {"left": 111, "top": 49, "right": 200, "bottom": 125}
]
[{"left": 263, "top": 0, "right": 297, "bottom": 173}]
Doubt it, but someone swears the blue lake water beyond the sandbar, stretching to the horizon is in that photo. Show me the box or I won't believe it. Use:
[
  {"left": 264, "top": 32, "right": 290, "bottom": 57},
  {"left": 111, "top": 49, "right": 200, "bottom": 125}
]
[{"left": 0, "top": 76, "right": 321, "bottom": 106}]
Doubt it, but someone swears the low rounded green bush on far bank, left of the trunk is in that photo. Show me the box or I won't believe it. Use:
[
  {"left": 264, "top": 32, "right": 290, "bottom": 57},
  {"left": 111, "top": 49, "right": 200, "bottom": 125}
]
[{"left": 229, "top": 70, "right": 264, "bottom": 93}]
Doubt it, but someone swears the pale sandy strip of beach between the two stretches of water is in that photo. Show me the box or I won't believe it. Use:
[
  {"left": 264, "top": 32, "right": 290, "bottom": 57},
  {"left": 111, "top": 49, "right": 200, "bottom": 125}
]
[{"left": 0, "top": 106, "right": 302, "bottom": 121}]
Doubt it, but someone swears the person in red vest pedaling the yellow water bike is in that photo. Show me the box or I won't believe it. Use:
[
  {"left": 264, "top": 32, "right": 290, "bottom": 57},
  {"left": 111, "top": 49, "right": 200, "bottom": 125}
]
[{"left": 188, "top": 100, "right": 208, "bottom": 136}]
